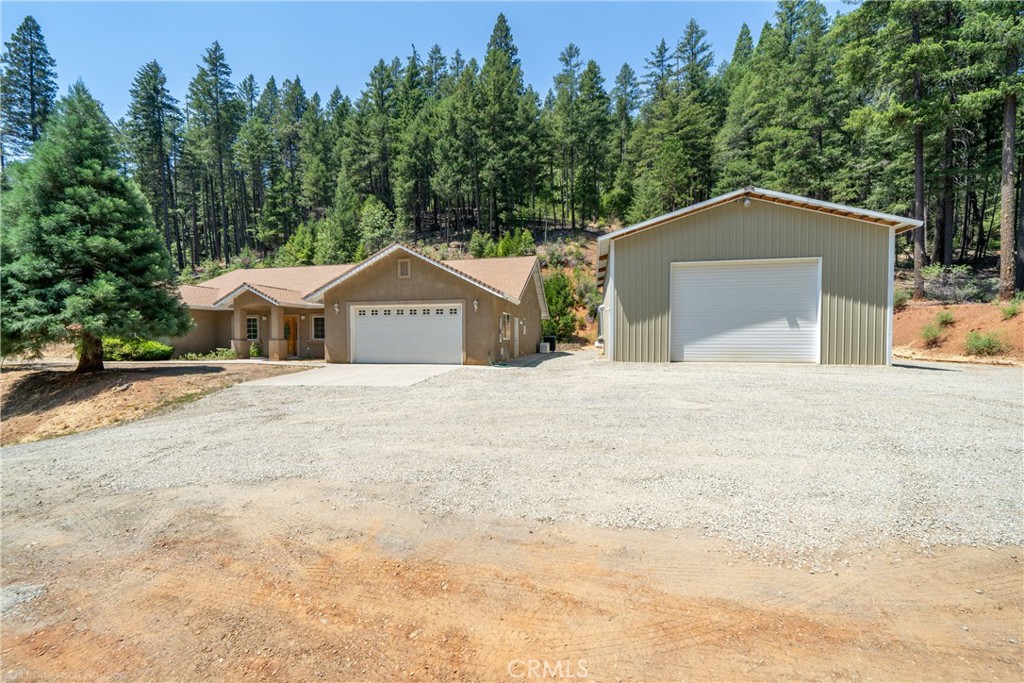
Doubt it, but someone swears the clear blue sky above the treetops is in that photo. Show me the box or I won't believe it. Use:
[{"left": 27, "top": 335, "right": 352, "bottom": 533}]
[{"left": 0, "top": 0, "right": 844, "bottom": 120}]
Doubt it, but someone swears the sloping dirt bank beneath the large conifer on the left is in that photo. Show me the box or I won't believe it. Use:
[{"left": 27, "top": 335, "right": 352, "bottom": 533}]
[{"left": 0, "top": 357, "right": 305, "bottom": 445}]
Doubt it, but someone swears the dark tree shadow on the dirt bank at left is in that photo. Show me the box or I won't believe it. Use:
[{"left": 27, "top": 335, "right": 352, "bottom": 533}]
[{"left": 0, "top": 365, "right": 224, "bottom": 419}]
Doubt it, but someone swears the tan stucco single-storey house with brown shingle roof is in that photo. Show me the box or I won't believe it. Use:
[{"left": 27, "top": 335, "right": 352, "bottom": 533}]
[{"left": 171, "top": 244, "right": 548, "bottom": 365}]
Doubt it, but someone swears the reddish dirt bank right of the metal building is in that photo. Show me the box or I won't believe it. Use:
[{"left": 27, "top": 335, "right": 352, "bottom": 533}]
[{"left": 893, "top": 301, "right": 1024, "bottom": 362}]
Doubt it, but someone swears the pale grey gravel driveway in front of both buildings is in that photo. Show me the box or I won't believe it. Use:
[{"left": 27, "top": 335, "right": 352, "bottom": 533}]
[{"left": 2, "top": 352, "right": 1024, "bottom": 556}]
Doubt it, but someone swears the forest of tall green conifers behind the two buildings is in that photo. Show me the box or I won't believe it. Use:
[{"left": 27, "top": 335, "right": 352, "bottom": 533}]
[{"left": 2, "top": 0, "right": 1024, "bottom": 296}]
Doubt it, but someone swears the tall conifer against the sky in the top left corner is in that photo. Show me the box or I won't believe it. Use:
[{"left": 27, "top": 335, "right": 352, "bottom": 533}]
[{"left": 0, "top": 16, "right": 57, "bottom": 168}]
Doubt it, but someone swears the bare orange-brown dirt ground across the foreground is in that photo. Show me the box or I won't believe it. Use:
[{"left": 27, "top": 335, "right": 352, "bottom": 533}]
[{"left": 2, "top": 481, "right": 1024, "bottom": 681}]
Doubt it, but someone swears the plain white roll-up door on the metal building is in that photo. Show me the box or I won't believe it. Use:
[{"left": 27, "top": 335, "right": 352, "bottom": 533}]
[{"left": 671, "top": 258, "right": 821, "bottom": 362}]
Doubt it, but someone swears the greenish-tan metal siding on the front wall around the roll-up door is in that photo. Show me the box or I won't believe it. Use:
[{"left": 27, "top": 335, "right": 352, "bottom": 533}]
[{"left": 611, "top": 200, "right": 892, "bottom": 365}]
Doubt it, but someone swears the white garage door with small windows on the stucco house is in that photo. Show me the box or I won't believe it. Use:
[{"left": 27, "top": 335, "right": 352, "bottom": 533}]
[{"left": 350, "top": 303, "right": 462, "bottom": 365}]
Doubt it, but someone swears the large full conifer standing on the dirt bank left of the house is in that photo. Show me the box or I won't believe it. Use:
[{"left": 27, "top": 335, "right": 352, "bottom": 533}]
[{"left": 0, "top": 82, "right": 190, "bottom": 372}]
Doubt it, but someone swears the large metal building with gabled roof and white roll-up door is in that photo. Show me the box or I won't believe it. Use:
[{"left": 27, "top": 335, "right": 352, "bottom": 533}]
[{"left": 597, "top": 187, "right": 921, "bottom": 365}]
